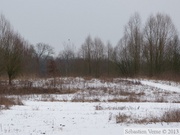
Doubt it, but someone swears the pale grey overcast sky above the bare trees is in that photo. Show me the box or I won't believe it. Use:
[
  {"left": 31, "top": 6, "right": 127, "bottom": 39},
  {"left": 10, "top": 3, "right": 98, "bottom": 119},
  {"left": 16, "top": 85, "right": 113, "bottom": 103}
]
[{"left": 0, "top": 0, "right": 180, "bottom": 53}]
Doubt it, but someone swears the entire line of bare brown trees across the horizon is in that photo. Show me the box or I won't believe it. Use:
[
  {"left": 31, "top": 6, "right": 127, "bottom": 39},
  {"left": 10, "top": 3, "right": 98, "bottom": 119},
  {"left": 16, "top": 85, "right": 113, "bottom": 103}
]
[{"left": 0, "top": 13, "right": 180, "bottom": 84}]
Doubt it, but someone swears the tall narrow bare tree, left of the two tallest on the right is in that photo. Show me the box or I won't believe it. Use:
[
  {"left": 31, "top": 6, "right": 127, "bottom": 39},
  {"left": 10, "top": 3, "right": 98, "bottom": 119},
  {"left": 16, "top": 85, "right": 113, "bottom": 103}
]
[{"left": 115, "top": 13, "right": 142, "bottom": 76}]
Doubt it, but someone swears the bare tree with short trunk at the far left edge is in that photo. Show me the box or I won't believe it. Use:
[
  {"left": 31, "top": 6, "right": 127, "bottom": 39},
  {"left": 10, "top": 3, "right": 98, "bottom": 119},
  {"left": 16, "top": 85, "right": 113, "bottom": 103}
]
[{"left": 0, "top": 13, "right": 24, "bottom": 85}]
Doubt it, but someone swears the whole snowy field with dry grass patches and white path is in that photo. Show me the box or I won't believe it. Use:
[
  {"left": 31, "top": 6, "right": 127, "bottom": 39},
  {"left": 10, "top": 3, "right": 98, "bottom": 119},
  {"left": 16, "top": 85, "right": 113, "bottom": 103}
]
[{"left": 0, "top": 78, "right": 180, "bottom": 135}]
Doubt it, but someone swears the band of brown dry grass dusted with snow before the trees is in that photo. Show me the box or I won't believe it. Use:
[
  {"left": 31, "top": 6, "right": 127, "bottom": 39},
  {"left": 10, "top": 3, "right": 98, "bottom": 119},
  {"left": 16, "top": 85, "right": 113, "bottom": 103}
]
[{"left": 0, "top": 77, "right": 180, "bottom": 102}]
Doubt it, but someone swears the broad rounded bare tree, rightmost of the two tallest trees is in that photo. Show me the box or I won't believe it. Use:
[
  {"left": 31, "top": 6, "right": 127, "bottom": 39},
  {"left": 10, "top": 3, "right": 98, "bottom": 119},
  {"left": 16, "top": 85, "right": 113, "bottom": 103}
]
[{"left": 144, "top": 13, "right": 176, "bottom": 76}]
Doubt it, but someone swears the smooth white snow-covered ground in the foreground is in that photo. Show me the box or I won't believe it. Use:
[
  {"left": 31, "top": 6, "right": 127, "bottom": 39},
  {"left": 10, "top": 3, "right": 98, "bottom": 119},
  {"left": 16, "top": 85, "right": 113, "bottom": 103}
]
[{"left": 0, "top": 101, "right": 180, "bottom": 135}]
